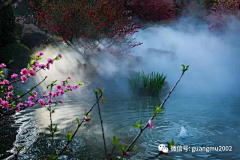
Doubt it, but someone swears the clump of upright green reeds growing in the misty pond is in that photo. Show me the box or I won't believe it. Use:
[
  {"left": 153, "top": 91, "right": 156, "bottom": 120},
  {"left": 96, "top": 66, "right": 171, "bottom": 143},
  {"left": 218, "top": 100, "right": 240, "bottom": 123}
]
[{"left": 128, "top": 71, "right": 167, "bottom": 96}]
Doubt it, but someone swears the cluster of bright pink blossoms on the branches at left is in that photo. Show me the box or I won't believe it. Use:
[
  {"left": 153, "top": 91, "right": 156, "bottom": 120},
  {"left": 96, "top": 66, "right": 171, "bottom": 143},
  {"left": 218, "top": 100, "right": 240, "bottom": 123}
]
[{"left": 0, "top": 53, "right": 78, "bottom": 112}]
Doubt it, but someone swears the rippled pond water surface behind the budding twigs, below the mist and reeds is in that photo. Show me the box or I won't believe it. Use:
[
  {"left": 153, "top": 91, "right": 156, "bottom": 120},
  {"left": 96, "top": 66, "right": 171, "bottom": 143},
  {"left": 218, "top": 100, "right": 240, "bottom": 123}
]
[{"left": 2, "top": 94, "right": 240, "bottom": 160}]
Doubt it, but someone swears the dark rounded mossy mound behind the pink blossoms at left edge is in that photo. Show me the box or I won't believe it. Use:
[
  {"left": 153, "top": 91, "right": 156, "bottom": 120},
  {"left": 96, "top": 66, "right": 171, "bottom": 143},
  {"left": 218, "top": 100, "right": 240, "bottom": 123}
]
[{"left": 0, "top": 44, "right": 33, "bottom": 73}]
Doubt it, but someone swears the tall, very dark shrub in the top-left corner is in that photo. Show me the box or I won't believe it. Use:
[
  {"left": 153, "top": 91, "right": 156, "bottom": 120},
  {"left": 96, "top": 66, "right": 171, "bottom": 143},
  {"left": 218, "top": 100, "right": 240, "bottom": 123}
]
[{"left": 0, "top": 5, "right": 16, "bottom": 47}]
